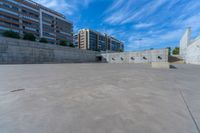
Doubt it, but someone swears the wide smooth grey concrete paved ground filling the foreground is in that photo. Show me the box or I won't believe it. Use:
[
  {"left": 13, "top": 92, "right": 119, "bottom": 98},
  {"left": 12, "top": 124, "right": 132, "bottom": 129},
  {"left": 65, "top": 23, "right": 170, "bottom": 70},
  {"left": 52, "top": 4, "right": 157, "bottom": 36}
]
[{"left": 0, "top": 64, "right": 200, "bottom": 133}]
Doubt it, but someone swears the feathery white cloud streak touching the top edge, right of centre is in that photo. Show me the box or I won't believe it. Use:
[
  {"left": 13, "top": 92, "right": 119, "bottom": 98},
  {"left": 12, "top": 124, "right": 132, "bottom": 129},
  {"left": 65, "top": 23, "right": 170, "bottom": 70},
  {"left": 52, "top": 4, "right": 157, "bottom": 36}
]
[{"left": 105, "top": 0, "right": 168, "bottom": 24}]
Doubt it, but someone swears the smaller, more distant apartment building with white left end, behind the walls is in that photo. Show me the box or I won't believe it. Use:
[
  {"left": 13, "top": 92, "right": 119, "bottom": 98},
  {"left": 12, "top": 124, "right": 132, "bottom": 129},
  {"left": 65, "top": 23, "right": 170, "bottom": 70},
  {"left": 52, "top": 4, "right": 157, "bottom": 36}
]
[{"left": 78, "top": 29, "right": 124, "bottom": 52}]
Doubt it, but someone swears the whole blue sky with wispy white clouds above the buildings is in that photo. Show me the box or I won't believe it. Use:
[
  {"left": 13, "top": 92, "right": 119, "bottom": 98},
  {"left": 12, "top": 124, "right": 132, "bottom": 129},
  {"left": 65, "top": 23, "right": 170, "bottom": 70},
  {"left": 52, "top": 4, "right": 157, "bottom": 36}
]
[{"left": 34, "top": 0, "right": 200, "bottom": 51}]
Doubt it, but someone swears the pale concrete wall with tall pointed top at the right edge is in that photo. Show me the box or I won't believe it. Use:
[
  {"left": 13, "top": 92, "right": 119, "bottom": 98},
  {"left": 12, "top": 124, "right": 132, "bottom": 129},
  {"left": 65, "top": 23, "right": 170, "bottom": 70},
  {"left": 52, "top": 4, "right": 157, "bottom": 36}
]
[{"left": 180, "top": 28, "right": 200, "bottom": 65}]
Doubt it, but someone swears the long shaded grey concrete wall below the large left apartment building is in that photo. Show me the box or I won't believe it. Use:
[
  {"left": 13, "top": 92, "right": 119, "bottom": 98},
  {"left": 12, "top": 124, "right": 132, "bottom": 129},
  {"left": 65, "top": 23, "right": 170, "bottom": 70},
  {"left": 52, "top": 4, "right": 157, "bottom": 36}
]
[{"left": 0, "top": 37, "right": 98, "bottom": 64}]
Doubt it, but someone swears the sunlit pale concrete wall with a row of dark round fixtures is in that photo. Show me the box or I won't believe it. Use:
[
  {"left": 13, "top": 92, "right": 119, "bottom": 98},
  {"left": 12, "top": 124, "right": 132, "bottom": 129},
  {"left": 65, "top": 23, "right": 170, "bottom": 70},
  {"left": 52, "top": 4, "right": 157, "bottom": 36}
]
[{"left": 101, "top": 49, "right": 168, "bottom": 63}]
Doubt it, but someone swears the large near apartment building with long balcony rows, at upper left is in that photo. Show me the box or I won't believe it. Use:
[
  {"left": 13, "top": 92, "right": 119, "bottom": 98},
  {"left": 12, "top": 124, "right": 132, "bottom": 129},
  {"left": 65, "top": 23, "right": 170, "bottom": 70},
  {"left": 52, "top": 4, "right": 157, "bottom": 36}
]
[{"left": 0, "top": 0, "right": 73, "bottom": 44}]
